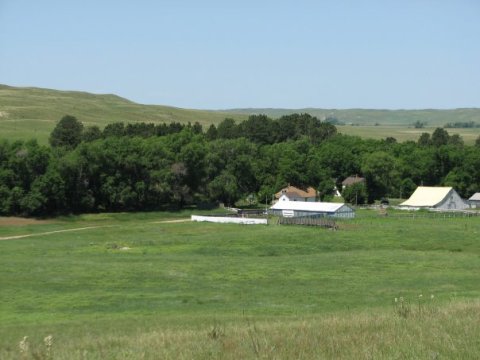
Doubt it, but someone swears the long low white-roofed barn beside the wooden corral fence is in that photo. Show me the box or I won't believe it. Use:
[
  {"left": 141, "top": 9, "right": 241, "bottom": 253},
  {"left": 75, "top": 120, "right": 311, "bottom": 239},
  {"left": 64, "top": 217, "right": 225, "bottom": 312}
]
[{"left": 270, "top": 201, "right": 355, "bottom": 218}]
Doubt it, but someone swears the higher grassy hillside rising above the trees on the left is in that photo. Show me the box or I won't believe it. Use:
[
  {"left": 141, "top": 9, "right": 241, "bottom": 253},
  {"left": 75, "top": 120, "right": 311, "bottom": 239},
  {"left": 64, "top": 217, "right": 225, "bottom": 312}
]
[{"left": 0, "top": 85, "right": 247, "bottom": 143}]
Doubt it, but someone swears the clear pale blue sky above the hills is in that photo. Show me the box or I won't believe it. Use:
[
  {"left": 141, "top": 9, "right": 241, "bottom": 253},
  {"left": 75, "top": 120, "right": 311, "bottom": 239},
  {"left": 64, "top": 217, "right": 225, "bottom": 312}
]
[{"left": 0, "top": 0, "right": 480, "bottom": 109}]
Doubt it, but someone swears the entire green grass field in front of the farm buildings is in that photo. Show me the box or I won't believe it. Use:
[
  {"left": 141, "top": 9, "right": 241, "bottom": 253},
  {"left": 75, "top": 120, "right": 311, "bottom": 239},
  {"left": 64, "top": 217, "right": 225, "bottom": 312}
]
[{"left": 0, "top": 210, "right": 480, "bottom": 359}]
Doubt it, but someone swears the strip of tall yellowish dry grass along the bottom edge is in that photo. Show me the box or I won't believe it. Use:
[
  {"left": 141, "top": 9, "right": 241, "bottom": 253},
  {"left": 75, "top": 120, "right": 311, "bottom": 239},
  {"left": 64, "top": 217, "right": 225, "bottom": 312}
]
[{"left": 4, "top": 301, "right": 480, "bottom": 359}]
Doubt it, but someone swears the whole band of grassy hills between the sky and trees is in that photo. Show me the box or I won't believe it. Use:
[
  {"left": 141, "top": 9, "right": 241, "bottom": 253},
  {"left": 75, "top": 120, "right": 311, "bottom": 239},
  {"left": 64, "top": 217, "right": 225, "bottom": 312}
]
[{"left": 0, "top": 85, "right": 480, "bottom": 143}]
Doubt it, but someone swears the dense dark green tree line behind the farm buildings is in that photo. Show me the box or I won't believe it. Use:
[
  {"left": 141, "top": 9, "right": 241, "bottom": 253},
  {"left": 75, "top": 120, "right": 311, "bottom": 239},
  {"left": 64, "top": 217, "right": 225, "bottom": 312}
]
[{"left": 0, "top": 114, "right": 480, "bottom": 216}]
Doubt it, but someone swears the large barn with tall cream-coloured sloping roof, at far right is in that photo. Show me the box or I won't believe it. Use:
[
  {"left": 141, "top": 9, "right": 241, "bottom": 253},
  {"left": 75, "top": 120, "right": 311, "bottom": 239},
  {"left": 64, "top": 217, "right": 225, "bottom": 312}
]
[{"left": 400, "top": 186, "right": 469, "bottom": 210}]
